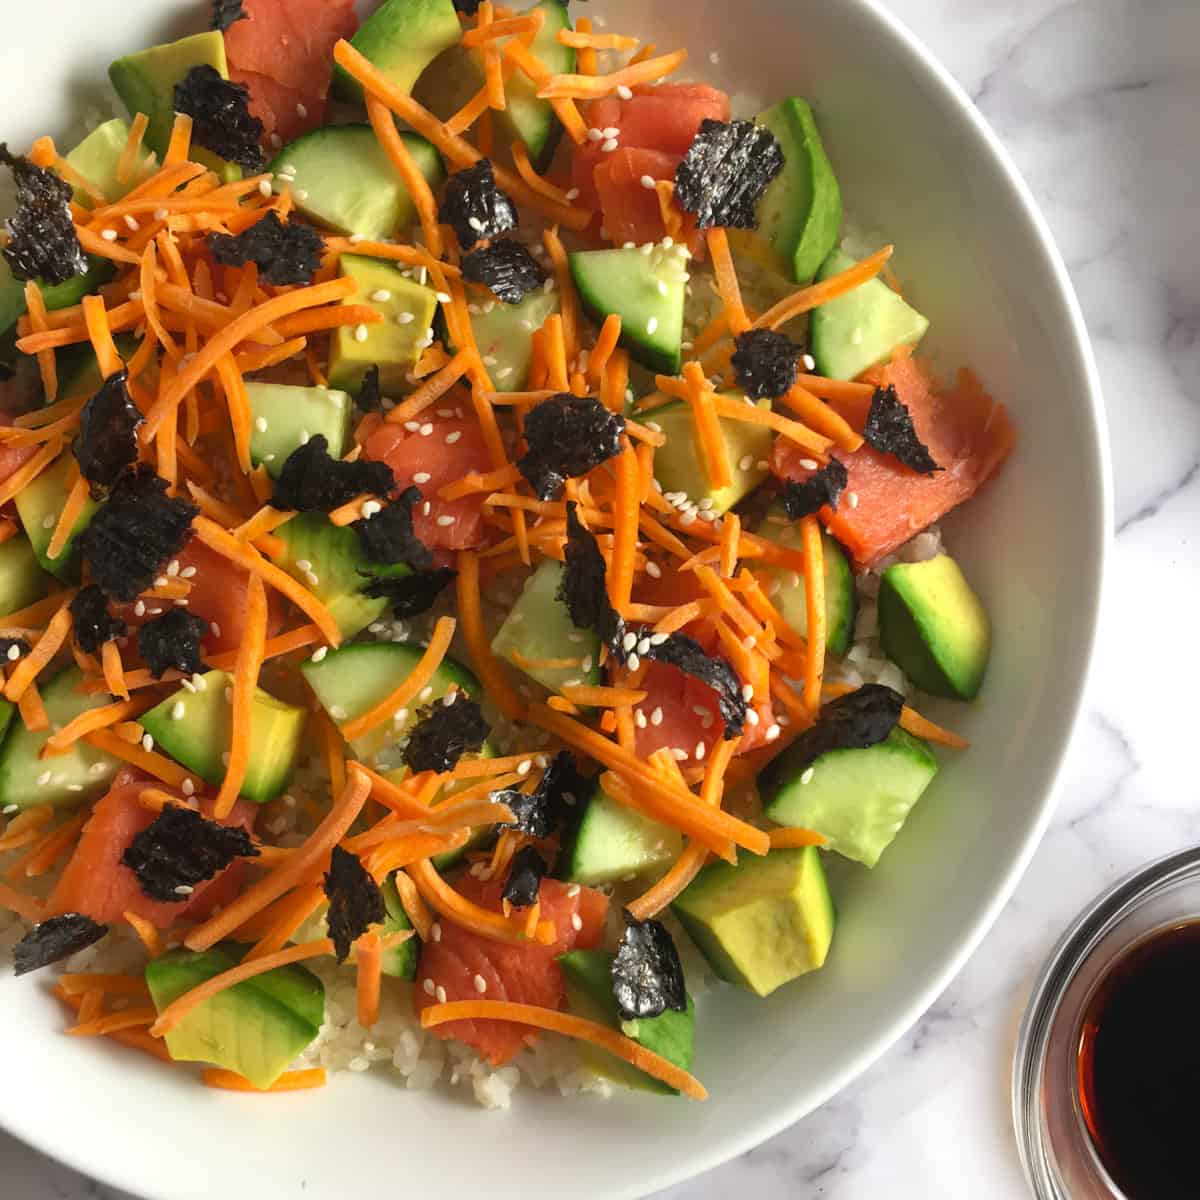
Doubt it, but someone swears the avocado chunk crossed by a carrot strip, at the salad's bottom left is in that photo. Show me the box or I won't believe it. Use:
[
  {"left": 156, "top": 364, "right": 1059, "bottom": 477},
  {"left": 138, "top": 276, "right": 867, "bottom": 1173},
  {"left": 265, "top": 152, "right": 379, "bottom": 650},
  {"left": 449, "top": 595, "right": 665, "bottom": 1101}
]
[{"left": 146, "top": 946, "right": 325, "bottom": 1087}]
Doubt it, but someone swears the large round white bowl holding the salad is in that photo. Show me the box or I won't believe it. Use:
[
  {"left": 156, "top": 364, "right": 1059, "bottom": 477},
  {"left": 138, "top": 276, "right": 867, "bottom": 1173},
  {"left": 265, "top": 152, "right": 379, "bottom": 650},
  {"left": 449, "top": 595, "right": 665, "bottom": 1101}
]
[{"left": 0, "top": 0, "right": 1110, "bottom": 1200}]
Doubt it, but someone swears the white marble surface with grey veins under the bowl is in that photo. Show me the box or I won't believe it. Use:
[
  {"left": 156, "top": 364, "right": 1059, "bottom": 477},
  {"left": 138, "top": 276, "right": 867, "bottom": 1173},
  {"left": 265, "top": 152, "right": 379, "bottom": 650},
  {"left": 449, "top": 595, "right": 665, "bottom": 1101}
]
[{"left": 0, "top": 0, "right": 1200, "bottom": 1200}]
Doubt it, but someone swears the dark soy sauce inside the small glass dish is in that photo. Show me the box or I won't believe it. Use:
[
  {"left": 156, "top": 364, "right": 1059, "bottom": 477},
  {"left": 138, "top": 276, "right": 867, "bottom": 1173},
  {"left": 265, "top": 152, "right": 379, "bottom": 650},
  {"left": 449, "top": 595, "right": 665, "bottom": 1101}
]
[{"left": 1079, "top": 922, "right": 1200, "bottom": 1200}]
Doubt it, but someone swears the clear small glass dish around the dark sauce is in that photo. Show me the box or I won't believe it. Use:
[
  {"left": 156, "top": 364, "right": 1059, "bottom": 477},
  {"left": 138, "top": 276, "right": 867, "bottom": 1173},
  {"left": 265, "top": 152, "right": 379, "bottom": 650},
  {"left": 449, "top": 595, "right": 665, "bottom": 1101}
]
[{"left": 1013, "top": 846, "right": 1200, "bottom": 1200}]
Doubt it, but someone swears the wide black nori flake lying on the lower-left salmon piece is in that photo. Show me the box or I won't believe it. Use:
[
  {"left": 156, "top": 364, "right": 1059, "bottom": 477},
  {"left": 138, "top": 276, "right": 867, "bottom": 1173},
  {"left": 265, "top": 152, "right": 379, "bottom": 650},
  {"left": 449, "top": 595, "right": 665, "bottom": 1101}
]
[{"left": 121, "top": 804, "right": 259, "bottom": 904}]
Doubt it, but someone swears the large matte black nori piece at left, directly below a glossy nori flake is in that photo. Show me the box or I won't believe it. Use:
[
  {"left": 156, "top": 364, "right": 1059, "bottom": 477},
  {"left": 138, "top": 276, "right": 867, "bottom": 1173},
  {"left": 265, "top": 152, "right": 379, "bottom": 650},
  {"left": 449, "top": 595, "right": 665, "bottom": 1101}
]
[{"left": 76, "top": 464, "right": 199, "bottom": 600}]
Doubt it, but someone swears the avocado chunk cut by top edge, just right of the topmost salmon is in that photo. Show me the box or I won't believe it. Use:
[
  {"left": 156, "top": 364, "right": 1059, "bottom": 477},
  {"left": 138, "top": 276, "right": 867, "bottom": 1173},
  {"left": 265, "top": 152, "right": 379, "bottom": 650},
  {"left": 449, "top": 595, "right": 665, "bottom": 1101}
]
[{"left": 334, "top": 0, "right": 462, "bottom": 102}]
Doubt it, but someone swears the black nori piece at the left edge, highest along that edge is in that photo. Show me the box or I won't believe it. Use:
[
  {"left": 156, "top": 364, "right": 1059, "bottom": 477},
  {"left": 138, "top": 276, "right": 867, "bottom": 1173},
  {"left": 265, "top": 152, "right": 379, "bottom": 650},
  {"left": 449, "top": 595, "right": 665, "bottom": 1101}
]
[{"left": 0, "top": 142, "right": 88, "bottom": 283}]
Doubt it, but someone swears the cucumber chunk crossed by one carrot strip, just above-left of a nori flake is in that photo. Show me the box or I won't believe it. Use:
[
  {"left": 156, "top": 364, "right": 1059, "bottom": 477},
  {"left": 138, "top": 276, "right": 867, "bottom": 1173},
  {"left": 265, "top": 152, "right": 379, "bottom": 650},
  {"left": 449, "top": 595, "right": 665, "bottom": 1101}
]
[{"left": 300, "top": 642, "right": 484, "bottom": 758}]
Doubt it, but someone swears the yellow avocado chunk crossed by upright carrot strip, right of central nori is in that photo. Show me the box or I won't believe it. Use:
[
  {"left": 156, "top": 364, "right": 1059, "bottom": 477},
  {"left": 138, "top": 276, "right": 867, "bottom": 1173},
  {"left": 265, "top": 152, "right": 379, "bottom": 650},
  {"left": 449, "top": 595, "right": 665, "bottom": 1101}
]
[{"left": 649, "top": 395, "right": 775, "bottom": 512}]
